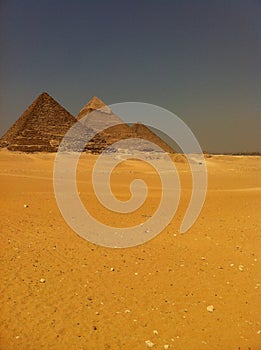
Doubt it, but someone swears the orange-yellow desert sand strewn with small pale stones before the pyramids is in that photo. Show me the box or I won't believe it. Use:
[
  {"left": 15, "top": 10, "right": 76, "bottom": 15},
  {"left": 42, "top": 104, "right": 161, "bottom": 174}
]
[{"left": 0, "top": 150, "right": 261, "bottom": 350}]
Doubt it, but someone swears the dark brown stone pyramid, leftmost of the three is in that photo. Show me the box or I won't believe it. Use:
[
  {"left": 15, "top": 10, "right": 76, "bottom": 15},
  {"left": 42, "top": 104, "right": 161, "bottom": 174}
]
[{"left": 0, "top": 92, "right": 76, "bottom": 152}]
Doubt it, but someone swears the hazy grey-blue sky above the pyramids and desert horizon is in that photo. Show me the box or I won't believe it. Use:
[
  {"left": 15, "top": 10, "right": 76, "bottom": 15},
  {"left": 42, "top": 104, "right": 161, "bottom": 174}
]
[{"left": 0, "top": 0, "right": 261, "bottom": 152}]
